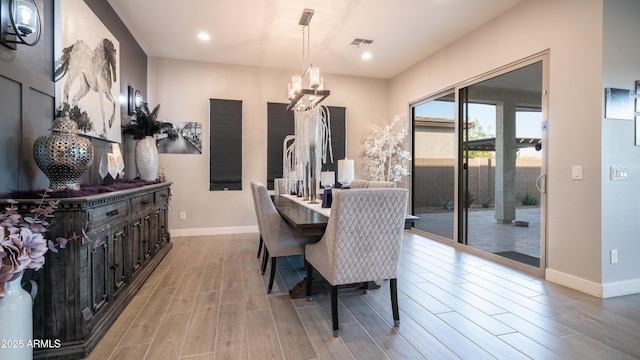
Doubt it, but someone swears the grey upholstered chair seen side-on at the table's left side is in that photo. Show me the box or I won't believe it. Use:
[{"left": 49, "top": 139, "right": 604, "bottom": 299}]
[{"left": 252, "top": 183, "right": 318, "bottom": 293}]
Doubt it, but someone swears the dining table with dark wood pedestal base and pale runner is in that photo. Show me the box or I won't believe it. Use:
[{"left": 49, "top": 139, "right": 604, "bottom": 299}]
[{"left": 273, "top": 190, "right": 418, "bottom": 298}]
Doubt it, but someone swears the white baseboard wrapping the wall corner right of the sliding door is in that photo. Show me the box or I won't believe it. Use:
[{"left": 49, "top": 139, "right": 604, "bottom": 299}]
[{"left": 545, "top": 269, "right": 640, "bottom": 299}]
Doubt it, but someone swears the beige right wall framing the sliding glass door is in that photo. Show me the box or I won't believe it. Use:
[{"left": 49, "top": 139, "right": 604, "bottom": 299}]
[{"left": 390, "top": 0, "right": 603, "bottom": 294}]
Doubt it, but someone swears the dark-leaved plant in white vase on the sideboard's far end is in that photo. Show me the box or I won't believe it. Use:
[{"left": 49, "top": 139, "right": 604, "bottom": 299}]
[{"left": 122, "top": 103, "right": 166, "bottom": 181}]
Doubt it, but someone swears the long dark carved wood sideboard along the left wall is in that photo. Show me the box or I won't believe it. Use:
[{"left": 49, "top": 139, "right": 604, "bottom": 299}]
[{"left": 0, "top": 183, "right": 172, "bottom": 359}]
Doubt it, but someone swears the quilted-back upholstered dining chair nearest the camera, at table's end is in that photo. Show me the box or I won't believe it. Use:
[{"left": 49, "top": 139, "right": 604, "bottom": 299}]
[{"left": 305, "top": 189, "right": 409, "bottom": 336}]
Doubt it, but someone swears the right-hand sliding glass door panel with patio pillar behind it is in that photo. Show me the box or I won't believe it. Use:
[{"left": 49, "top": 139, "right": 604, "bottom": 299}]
[{"left": 458, "top": 61, "right": 544, "bottom": 268}]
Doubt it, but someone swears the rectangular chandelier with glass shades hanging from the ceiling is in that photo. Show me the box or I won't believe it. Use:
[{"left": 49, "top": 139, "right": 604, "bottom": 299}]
[{"left": 287, "top": 9, "right": 330, "bottom": 110}]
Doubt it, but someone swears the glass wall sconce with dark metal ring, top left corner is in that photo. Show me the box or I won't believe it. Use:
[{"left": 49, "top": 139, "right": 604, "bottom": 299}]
[{"left": 0, "top": 0, "right": 42, "bottom": 50}]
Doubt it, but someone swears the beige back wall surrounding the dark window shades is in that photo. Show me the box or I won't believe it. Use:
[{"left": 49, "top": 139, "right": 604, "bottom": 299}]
[{"left": 147, "top": 58, "right": 389, "bottom": 236}]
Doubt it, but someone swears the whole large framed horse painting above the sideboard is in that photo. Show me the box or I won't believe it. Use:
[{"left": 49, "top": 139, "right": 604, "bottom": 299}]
[{"left": 53, "top": 0, "right": 122, "bottom": 143}]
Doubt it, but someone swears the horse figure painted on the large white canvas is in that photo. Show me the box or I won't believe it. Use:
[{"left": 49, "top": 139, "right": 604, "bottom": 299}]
[{"left": 56, "top": 39, "right": 118, "bottom": 138}]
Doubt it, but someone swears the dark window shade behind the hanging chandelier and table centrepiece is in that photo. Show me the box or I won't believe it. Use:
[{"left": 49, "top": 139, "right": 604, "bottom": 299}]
[{"left": 267, "top": 103, "right": 347, "bottom": 189}]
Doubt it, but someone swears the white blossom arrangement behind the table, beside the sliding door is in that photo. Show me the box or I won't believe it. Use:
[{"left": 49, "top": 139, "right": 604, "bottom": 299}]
[{"left": 358, "top": 115, "right": 411, "bottom": 182}]
